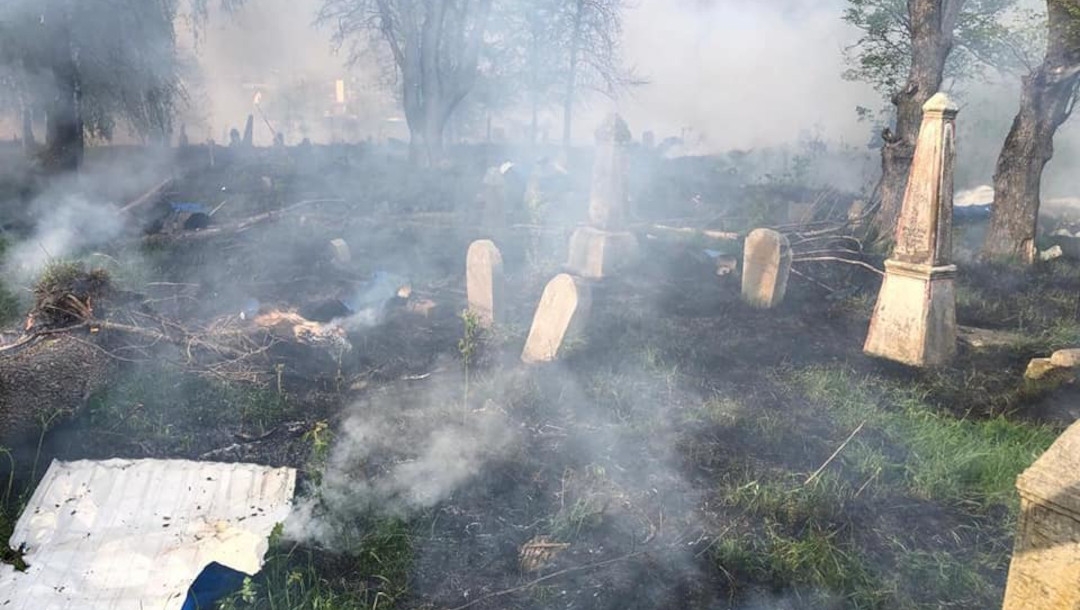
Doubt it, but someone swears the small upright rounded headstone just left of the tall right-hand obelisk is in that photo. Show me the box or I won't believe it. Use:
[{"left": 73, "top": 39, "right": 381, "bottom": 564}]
[{"left": 742, "top": 229, "right": 792, "bottom": 309}]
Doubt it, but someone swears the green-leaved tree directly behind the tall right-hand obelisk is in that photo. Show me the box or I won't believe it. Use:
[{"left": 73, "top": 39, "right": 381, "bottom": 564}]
[{"left": 843, "top": 0, "right": 1022, "bottom": 240}]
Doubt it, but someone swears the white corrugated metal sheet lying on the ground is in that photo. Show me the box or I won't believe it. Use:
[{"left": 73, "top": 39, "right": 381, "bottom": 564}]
[{"left": 0, "top": 460, "right": 296, "bottom": 610}]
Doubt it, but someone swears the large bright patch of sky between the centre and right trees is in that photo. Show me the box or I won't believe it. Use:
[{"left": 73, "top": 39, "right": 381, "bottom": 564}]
[{"left": 604, "top": 0, "right": 880, "bottom": 151}]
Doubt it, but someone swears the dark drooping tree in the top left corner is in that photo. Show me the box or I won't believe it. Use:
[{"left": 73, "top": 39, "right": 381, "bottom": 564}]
[{"left": 0, "top": 0, "right": 238, "bottom": 171}]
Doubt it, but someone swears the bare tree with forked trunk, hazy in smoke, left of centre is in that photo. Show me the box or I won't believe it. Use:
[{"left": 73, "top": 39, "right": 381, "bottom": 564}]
[{"left": 319, "top": 0, "right": 491, "bottom": 164}]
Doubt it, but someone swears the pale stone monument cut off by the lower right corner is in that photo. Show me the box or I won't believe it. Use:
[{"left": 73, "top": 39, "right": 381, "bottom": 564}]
[{"left": 1004, "top": 423, "right": 1080, "bottom": 610}]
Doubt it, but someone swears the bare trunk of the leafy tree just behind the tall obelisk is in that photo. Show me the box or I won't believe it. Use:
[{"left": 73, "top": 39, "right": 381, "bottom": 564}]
[{"left": 874, "top": 0, "right": 964, "bottom": 243}]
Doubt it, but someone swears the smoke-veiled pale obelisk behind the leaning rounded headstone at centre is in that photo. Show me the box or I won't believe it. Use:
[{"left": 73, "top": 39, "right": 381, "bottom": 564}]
[{"left": 566, "top": 114, "right": 637, "bottom": 280}]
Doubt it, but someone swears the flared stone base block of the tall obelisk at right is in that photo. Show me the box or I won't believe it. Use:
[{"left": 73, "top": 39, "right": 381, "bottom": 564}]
[{"left": 863, "top": 260, "right": 957, "bottom": 366}]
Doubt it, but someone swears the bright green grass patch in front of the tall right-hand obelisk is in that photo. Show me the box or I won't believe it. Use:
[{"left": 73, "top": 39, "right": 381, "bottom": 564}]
[{"left": 785, "top": 367, "right": 1056, "bottom": 509}]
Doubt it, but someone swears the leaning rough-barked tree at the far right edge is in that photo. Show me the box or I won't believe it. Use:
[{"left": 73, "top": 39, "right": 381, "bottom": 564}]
[{"left": 983, "top": 0, "right": 1080, "bottom": 263}]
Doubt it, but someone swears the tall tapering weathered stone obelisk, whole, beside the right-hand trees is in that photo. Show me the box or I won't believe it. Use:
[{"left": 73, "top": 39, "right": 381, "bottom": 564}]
[{"left": 863, "top": 93, "right": 957, "bottom": 366}]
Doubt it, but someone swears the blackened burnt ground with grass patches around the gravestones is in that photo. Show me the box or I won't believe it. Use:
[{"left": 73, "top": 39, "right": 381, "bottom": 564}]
[{"left": 0, "top": 147, "right": 1080, "bottom": 609}]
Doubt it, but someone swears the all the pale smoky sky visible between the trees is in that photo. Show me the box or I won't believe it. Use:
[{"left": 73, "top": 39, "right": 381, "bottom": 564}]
[{"left": 168, "top": 0, "right": 1080, "bottom": 192}]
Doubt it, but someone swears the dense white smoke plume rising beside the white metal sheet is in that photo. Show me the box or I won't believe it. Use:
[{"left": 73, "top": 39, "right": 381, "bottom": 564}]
[{"left": 285, "top": 363, "right": 518, "bottom": 546}]
